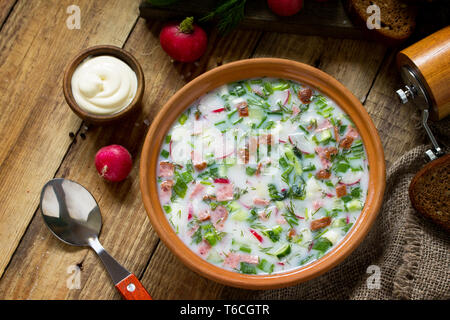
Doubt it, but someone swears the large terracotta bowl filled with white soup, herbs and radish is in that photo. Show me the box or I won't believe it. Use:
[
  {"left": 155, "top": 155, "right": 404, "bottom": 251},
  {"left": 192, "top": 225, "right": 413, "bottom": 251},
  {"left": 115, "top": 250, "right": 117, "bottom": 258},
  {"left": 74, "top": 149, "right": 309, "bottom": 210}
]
[{"left": 140, "top": 58, "right": 385, "bottom": 289}]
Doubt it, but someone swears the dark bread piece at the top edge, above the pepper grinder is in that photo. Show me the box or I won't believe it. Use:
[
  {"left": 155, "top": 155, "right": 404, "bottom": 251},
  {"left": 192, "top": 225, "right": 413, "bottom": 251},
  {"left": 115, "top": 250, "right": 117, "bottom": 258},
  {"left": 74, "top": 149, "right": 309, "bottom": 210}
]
[{"left": 344, "top": 0, "right": 417, "bottom": 46}]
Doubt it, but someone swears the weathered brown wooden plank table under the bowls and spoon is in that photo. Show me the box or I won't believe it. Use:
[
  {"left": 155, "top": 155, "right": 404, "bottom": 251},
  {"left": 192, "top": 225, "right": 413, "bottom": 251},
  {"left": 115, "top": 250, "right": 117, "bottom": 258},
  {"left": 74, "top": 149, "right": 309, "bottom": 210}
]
[{"left": 0, "top": 0, "right": 420, "bottom": 299}]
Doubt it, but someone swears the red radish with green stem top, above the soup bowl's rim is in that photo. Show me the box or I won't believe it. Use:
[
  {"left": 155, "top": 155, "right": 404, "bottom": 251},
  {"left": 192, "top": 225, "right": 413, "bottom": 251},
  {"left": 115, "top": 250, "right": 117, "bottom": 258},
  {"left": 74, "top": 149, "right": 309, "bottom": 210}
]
[{"left": 159, "top": 17, "right": 208, "bottom": 62}]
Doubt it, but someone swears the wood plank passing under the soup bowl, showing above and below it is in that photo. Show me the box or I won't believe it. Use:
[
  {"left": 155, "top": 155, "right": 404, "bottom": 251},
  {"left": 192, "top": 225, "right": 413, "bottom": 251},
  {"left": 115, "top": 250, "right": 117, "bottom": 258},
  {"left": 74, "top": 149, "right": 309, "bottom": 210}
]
[{"left": 143, "top": 33, "right": 386, "bottom": 299}]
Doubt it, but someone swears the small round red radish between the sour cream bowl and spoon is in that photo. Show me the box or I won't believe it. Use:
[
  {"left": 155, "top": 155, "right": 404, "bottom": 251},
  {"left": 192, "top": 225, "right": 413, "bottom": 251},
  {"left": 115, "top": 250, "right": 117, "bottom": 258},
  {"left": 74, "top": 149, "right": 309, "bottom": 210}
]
[{"left": 95, "top": 144, "right": 133, "bottom": 182}]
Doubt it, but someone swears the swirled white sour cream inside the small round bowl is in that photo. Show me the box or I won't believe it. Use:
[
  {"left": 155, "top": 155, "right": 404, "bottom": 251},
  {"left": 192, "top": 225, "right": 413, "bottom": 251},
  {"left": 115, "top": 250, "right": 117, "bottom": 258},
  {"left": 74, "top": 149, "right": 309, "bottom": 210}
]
[{"left": 71, "top": 56, "right": 138, "bottom": 115}]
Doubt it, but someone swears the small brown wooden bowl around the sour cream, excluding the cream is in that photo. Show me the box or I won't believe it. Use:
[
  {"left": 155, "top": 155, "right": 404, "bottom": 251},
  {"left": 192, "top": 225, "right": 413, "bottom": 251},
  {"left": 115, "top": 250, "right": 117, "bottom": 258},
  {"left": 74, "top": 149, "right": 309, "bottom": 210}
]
[{"left": 63, "top": 45, "right": 145, "bottom": 125}]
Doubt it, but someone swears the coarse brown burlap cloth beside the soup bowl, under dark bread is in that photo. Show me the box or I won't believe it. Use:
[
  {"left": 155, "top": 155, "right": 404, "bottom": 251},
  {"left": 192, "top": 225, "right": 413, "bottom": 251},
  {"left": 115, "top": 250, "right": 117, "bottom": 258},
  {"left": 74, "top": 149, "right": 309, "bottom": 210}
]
[{"left": 252, "top": 119, "right": 450, "bottom": 300}]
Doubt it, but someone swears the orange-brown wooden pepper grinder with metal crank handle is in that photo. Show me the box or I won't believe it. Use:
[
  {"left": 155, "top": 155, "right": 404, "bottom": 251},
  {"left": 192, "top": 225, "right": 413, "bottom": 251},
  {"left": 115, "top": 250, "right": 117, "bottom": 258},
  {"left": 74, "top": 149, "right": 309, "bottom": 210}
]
[{"left": 396, "top": 26, "right": 450, "bottom": 160}]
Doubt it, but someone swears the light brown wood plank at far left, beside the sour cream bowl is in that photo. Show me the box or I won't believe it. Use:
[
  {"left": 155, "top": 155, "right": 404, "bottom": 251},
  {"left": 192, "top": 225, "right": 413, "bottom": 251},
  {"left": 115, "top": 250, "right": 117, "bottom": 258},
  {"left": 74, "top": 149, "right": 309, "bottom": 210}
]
[{"left": 0, "top": 0, "right": 138, "bottom": 275}]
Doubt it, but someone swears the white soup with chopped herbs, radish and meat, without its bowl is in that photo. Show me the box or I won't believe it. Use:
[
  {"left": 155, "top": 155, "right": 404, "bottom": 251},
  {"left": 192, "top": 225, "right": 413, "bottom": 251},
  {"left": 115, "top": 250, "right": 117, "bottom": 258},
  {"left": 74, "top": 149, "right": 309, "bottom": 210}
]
[{"left": 157, "top": 78, "right": 369, "bottom": 274}]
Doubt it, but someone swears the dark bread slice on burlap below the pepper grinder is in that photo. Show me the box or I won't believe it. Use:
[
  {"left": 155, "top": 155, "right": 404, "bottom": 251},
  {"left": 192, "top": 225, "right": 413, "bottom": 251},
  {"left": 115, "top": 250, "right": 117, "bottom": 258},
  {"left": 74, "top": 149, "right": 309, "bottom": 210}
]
[{"left": 409, "top": 154, "right": 450, "bottom": 232}]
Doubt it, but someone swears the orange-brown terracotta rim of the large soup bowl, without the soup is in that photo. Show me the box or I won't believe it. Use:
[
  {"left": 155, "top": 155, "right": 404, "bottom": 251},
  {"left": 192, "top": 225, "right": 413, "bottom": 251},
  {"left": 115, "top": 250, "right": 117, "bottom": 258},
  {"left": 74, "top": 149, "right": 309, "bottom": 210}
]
[{"left": 139, "top": 58, "right": 386, "bottom": 289}]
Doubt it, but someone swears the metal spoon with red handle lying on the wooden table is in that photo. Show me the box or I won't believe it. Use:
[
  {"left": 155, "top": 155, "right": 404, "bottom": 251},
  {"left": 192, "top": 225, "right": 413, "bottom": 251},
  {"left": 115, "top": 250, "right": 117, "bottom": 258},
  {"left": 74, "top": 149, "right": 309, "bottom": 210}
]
[{"left": 40, "top": 179, "right": 152, "bottom": 300}]
